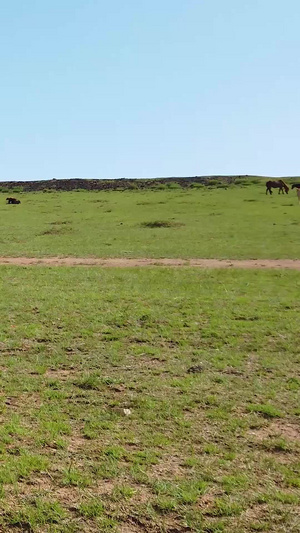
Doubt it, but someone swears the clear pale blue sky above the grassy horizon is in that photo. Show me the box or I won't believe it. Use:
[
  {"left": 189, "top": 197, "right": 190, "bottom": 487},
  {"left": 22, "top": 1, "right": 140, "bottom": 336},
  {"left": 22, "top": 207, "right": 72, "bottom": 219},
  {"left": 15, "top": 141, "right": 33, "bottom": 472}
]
[{"left": 0, "top": 0, "right": 300, "bottom": 181}]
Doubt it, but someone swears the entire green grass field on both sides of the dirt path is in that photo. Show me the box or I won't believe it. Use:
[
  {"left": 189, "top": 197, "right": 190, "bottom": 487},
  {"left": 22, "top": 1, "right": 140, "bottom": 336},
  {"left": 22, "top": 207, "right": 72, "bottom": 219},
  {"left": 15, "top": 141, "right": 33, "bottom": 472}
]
[{"left": 0, "top": 180, "right": 300, "bottom": 533}]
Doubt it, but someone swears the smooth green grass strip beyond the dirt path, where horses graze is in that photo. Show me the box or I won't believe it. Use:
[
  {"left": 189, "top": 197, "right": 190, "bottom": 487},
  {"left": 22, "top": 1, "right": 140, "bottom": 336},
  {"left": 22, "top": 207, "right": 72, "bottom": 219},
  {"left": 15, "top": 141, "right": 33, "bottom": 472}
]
[{"left": 0, "top": 180, "right": 300, "bottom": 259}]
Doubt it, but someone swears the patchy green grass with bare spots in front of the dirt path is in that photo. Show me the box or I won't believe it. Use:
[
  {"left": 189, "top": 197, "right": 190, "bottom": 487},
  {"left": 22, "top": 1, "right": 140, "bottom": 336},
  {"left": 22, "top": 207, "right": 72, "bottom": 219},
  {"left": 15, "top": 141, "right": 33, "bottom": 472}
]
[{"left": 0, "top": 268, "right": 300, "bottom": 533}]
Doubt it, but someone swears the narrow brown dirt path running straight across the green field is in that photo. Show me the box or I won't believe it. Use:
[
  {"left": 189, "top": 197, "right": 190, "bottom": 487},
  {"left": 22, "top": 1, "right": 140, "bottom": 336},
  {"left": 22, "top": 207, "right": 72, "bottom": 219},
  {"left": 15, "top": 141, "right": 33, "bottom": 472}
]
[{"left": 0, "top": 257, "right": 300, "bottom": 270}]
